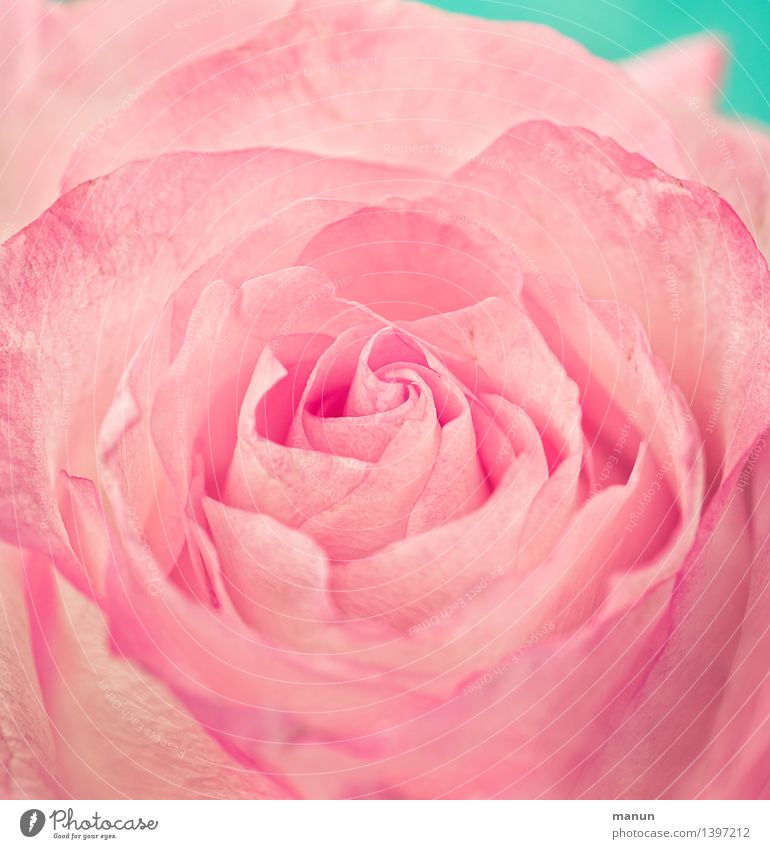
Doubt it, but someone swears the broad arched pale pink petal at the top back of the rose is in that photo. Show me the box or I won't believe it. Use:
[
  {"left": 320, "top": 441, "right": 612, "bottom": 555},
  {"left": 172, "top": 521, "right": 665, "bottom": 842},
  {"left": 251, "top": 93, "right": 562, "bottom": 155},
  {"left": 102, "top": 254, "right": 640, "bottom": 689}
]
[{"left": 63, "top": 0, "right": 681, "bottom": 185}]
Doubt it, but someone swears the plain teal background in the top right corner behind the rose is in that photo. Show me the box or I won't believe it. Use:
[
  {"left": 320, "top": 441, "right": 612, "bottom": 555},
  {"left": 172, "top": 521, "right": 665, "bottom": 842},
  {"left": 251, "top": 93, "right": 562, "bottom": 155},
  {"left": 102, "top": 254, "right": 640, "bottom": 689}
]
[{"left": 420, "top": 0, "right": 770, "bottom": 123}]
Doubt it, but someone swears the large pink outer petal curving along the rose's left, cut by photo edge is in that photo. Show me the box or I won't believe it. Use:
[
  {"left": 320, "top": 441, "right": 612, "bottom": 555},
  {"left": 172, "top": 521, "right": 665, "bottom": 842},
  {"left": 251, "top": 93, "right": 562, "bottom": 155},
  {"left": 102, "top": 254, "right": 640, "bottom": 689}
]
[{"left": 0, "top": 146, "right": 420, "bottom": 568}]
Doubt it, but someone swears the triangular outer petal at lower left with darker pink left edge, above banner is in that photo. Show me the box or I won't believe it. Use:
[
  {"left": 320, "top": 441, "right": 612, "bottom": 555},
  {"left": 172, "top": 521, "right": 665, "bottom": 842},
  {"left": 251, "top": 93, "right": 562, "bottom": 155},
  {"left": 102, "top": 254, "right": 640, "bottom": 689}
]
[{"left": 18, "top": 558, "right": 290, "bottom": 799}]
